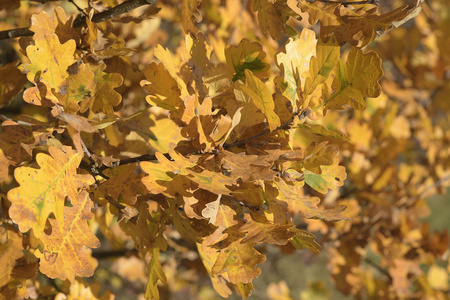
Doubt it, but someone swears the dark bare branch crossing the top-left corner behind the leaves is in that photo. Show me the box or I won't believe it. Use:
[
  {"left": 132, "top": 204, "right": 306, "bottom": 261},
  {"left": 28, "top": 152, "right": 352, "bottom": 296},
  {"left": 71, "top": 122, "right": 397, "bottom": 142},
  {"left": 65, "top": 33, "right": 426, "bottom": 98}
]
[{"left": 0, "top": 0, "right": 157, "bottom": 40}]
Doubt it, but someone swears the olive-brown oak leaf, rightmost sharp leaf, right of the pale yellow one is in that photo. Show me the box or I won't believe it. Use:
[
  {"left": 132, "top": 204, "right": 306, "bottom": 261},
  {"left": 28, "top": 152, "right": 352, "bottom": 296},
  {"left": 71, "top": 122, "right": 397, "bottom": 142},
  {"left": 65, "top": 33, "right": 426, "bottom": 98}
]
[{"left": 325, "top": 48, "right": 383, "bottom": 110}]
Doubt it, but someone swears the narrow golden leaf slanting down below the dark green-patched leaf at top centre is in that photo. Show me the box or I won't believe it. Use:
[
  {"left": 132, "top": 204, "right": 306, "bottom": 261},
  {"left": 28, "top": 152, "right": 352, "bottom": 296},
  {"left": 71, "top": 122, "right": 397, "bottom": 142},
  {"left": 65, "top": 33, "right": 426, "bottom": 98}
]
[{"left": 241, "top": 69, "right": 281, "bottom": 131}]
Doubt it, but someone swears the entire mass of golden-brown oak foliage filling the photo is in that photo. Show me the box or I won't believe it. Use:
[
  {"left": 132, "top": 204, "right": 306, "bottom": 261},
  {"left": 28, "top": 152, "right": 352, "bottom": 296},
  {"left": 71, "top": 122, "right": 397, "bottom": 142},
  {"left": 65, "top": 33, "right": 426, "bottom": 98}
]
[{"left": 0, "top": 0, "right": 450, "bottom": 299}]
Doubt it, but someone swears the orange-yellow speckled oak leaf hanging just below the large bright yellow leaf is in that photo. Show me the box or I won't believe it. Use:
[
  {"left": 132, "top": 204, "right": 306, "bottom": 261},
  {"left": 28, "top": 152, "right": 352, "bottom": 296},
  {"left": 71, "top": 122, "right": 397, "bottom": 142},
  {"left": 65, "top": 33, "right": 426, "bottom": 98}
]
[{"left": 35, "top": 191, "right": 100, "bottom": 283}]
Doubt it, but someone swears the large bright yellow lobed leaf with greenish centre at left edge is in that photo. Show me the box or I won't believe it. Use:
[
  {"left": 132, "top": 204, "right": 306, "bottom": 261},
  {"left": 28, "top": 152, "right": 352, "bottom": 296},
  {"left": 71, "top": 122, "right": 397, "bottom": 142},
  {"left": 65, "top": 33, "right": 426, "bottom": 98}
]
[{"left": 8, "top": 146, "right": 94, "bottom": 238}]
